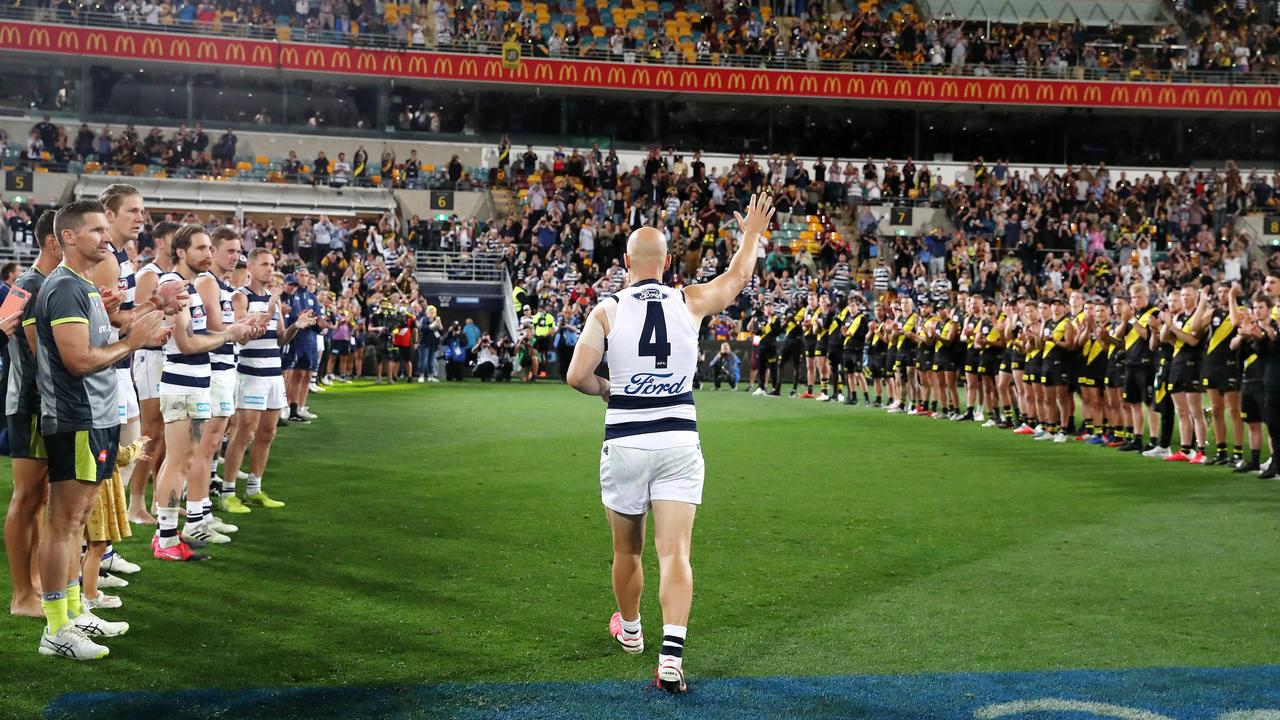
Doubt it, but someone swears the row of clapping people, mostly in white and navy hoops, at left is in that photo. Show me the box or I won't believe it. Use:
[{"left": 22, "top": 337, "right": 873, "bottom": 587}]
[{"left": 5, "top": 184, "right": 320, "bottom": 660}]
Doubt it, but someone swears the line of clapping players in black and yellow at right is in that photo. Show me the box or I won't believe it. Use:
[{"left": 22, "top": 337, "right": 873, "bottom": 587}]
[{"left": 749, "top": 277, "right": 1280, "bottom": 478}]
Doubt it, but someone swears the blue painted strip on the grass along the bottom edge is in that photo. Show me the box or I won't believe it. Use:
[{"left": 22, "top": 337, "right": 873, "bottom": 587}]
[{"left": 45, "top": 666, "right": 1280, "bottom": 720}]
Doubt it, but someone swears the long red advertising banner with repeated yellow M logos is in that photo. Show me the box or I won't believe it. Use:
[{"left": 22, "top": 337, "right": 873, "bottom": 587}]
[{"left": 0, "top": 22, "right": 1280, "bottom": 113}]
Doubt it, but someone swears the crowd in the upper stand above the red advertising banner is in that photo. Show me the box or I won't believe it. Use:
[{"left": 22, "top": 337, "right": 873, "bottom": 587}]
[{"left": 6, "top": 0, "right": 1280, "bottom": 79}]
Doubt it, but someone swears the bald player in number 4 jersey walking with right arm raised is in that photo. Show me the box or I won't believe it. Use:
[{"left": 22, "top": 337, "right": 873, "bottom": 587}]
[{"left": 567, "top": 195, "right": 773, "bottom": 693}]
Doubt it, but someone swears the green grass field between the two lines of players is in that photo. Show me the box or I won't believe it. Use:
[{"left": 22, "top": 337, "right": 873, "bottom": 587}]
[{"left": 0, "top": 382, "right": 1280, "bottom": 717}]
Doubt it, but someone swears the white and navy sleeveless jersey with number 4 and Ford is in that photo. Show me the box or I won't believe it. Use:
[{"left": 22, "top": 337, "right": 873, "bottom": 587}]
[{"left": 604, "top": 279, "right": 698, "bottom": 450}]
